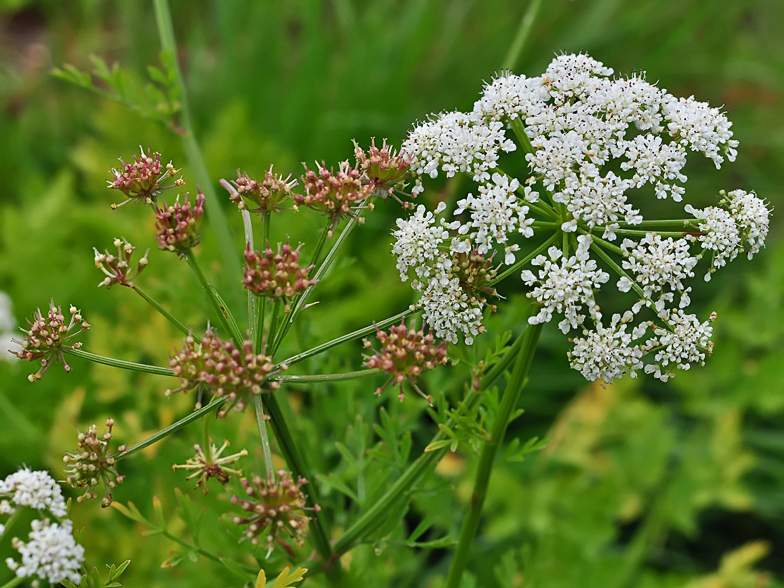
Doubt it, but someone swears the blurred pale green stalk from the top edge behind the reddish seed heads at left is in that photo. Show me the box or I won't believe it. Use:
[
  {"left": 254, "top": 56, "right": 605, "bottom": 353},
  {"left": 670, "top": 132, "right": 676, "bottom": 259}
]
[{"left": 153, "top": 0, "right": 242, "bottom": 290}]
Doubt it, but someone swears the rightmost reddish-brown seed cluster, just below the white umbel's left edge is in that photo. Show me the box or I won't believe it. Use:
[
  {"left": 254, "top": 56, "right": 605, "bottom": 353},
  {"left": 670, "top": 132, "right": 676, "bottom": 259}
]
[{"left": 362, "top": 319, "right": 447, "bottom": 404}]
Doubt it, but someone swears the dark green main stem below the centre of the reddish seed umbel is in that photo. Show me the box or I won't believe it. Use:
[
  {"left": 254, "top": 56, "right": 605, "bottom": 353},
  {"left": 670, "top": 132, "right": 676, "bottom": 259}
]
[{"left": 262, "top": 392, "right": 340, "bottom": 579}]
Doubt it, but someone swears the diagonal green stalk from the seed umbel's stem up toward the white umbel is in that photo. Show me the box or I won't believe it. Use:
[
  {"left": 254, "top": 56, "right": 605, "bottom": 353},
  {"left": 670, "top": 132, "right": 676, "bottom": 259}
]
[{"left": 335, "top": 322, "right": 527, "bottom": 557}]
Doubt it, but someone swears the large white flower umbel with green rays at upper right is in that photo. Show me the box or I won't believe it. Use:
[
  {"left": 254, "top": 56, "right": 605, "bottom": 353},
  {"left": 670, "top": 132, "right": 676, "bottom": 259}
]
[{"left": 392, "top": 55, "right": 770, "bottom": 382}]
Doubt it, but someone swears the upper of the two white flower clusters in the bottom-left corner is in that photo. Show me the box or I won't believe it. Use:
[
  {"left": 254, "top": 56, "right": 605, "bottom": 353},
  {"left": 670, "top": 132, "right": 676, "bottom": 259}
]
[{"left": 0, "top": 468, "right": 67, "bottom": 518}]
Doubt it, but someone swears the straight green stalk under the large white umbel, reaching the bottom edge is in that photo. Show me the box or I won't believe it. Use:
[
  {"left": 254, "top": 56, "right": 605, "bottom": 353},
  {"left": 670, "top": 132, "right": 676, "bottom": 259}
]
[{"left": 446, "top": 324, "right": 542, "bottom": 588}]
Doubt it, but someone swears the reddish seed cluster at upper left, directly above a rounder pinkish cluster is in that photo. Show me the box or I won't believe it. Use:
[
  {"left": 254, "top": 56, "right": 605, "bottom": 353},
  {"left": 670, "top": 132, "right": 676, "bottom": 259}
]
[{"left": 108, "top": 149, "right": 185, "bottom": 209}]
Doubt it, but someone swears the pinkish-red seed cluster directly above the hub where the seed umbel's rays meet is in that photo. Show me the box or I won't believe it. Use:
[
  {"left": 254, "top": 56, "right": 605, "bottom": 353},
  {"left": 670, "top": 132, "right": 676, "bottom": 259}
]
[{"left": 242, "top": 240, "right": 317, "bottom": 314}]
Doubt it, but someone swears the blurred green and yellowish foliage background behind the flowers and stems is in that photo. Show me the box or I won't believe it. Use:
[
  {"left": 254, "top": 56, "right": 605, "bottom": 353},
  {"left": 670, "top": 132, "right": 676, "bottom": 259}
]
[{"left": 0, "top": 0, "right": 784, "bottom": 588}]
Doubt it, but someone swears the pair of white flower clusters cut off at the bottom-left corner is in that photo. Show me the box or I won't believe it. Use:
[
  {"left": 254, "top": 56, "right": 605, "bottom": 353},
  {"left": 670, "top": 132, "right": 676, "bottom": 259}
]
[{"left": 0, "top": 468, "right": 84, "bottom": 584}]
